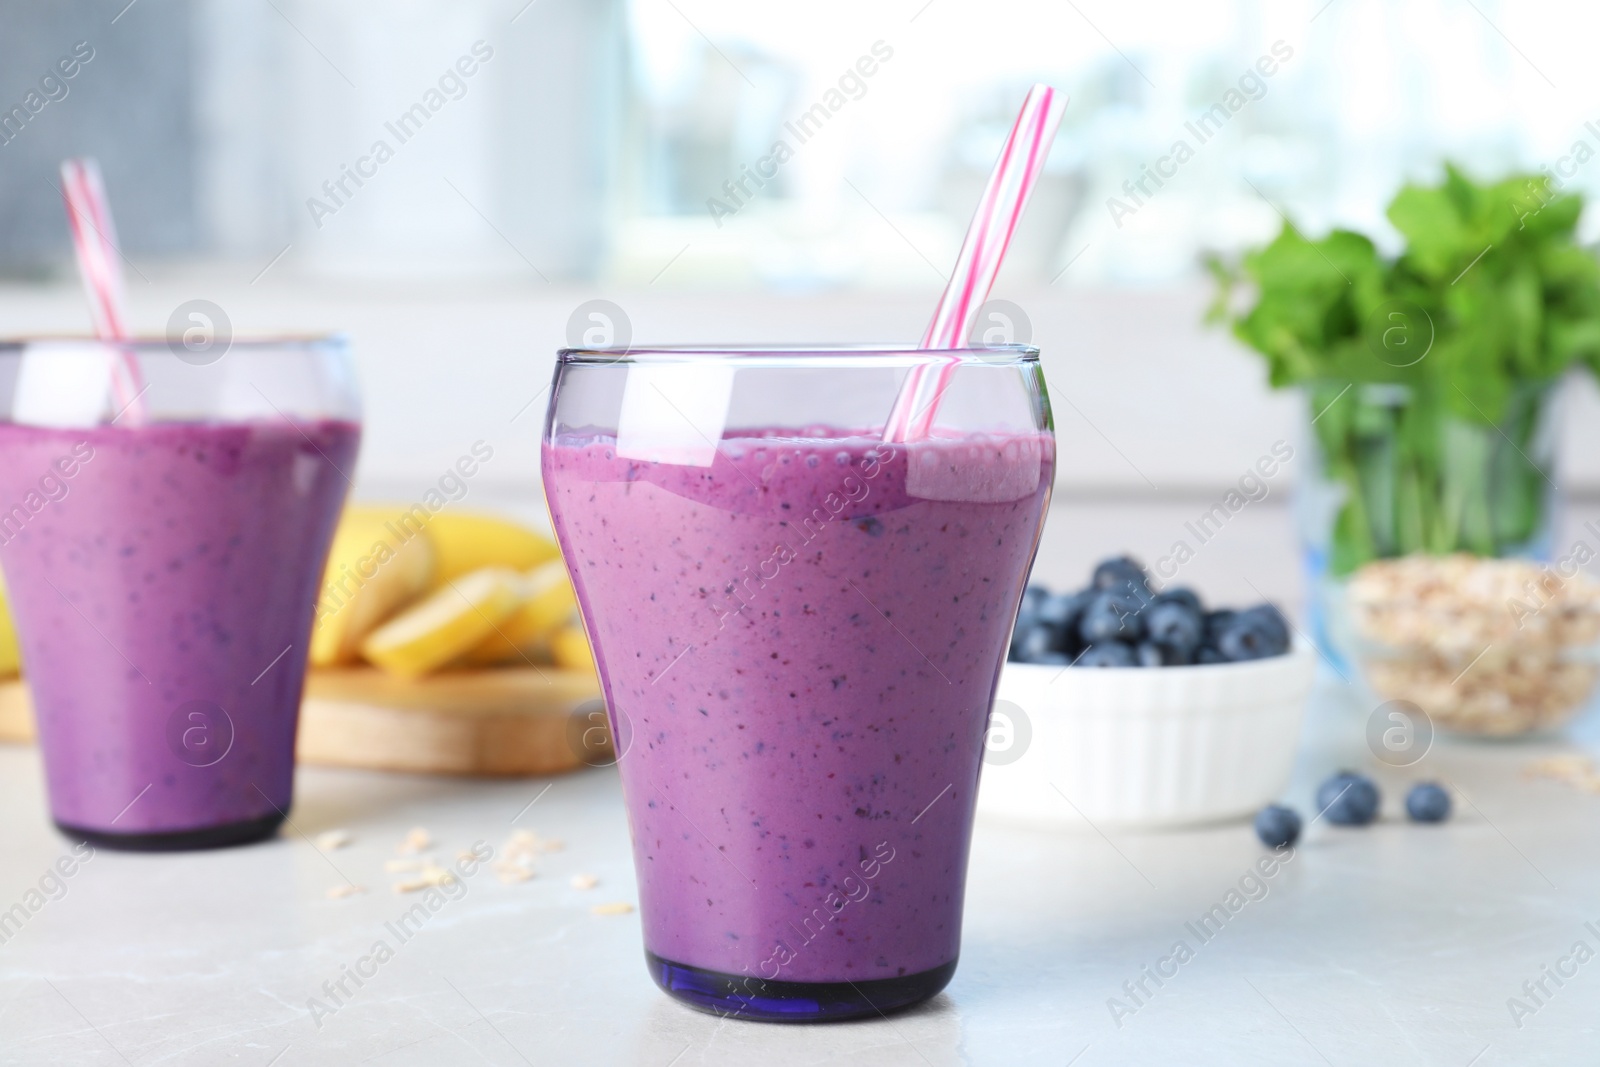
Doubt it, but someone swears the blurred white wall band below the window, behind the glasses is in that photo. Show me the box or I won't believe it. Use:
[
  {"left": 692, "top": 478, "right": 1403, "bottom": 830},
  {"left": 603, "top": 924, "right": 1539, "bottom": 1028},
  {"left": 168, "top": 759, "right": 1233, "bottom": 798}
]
[{"left": 0, "top": 278, "right": 1600, "bottom": 502}]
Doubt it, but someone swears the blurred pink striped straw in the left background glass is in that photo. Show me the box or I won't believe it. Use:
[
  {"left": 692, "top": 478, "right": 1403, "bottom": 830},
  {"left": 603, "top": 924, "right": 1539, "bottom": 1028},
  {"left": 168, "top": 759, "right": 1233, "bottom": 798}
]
[{"left": 61, "top": 158, "right": 144, "bottom": 424}]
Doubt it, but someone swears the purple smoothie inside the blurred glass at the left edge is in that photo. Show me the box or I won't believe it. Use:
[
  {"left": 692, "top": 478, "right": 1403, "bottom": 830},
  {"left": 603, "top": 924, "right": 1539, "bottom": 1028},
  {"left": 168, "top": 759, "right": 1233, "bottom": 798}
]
[{"left": 0, "top": 421, "right": 360, "bottom": 835}]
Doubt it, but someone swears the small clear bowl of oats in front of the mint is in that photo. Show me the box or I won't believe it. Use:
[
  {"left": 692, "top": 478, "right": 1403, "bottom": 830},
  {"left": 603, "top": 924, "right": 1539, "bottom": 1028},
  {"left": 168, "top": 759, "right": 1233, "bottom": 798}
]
[{"left": 1336, "top": 553, "right": 1600, "bottom": 737}]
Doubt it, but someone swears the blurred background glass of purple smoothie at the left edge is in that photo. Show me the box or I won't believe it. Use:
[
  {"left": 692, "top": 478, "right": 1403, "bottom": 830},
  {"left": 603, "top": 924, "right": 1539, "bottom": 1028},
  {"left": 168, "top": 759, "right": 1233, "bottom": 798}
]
[{"left": 0, "top": 338, "right": 360, "bottom": 849}]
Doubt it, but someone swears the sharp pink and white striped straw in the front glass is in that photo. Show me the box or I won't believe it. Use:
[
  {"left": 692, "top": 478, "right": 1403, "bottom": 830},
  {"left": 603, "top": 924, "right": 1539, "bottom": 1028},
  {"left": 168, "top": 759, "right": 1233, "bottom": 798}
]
[{"left": 883, "top": 85, "right": 1067, "bottom": 442}]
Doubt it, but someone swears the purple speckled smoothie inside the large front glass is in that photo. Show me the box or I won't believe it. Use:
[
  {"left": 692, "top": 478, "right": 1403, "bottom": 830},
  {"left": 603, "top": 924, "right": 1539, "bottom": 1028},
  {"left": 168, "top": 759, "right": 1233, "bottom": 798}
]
[{"left": 544, "top": 427, "right": 1054, "bottom": 982}]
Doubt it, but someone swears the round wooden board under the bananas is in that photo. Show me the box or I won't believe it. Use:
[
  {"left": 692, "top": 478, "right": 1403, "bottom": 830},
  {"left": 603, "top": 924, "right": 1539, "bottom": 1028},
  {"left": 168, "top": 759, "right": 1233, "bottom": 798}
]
[{"left": 0, "top": 667, "right": 610, "bottom": 776}]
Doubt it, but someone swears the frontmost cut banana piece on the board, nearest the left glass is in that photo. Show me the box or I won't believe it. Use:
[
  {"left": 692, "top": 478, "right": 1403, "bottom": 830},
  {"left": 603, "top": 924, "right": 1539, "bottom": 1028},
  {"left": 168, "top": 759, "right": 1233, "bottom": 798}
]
[{"left": 362, "top": 566, "right": 526, "bottom": 678}]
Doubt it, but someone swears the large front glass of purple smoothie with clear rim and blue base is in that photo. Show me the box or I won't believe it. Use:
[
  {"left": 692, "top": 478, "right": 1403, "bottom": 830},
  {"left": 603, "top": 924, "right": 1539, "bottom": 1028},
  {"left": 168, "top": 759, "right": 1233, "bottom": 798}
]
[{"left": 542, "top": 346, "right": 1054, "bottom": 1021}]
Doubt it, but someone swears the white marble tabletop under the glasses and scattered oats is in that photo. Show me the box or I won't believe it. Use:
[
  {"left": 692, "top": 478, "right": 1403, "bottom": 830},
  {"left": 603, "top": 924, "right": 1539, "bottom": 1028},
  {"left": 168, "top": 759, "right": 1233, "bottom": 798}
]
[{"left": 0, "top": 688, "right": 1600, "bottom": 1067}]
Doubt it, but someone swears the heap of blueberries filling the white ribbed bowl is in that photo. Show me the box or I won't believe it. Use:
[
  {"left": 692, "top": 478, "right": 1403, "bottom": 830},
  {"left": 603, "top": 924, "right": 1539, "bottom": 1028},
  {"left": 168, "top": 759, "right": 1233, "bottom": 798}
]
[{"left": 1008, "top": 557, "right": 1290, "bottom": 667}]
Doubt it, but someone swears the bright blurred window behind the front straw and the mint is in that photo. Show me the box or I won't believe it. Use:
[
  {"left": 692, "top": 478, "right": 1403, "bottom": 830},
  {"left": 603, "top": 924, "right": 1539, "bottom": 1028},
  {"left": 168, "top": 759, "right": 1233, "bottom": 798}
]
[{"left": 616, "top": 0, "right": 1600, "bottom": 286}]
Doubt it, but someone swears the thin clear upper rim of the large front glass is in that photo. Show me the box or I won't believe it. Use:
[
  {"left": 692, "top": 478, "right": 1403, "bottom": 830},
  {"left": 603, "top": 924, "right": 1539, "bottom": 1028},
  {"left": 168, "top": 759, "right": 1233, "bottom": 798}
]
[{"left": 557, "top": 344, "right": 1038, "bottom": 368}]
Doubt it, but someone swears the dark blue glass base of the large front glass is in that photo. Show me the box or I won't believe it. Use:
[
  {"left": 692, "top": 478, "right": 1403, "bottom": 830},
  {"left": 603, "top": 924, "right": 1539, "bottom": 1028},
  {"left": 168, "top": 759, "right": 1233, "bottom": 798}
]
[{"left": 645, "top": 952, "right": 955, "bottom": 1022}]
